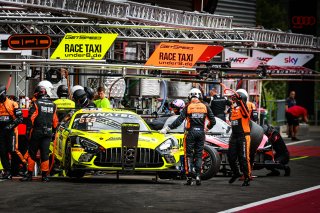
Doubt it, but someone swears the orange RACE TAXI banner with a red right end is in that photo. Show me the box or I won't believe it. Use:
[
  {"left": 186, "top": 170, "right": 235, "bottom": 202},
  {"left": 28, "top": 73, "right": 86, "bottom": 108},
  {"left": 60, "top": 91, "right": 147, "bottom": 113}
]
[{"left": 145, "top": 42, "right": 223, "bottom": 68}]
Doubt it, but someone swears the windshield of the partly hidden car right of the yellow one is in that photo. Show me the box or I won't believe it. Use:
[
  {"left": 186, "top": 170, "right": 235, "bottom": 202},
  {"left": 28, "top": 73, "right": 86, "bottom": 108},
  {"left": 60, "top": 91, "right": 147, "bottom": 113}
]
[{"left": 164, "top": 115, "right": 230, "bottom": 134}]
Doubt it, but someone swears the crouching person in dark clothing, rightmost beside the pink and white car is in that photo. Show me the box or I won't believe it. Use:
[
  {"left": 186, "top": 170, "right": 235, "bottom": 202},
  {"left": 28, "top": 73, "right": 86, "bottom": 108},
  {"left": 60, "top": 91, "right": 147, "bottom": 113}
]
[{"left": 263, "top": 125, "right": 291, "bottom": 176}]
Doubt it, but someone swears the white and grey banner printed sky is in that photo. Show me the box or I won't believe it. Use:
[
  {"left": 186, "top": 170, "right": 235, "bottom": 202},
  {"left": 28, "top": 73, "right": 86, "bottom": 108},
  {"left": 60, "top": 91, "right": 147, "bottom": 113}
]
[{"left": 267, "top": 53, "right": 314, "bottom": 66}]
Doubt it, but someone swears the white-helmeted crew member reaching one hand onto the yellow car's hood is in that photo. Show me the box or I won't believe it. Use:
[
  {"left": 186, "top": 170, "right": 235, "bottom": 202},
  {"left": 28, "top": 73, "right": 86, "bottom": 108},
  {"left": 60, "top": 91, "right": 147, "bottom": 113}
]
[{"left": 160, "top": 88, "right": 216, "bottom": 185}]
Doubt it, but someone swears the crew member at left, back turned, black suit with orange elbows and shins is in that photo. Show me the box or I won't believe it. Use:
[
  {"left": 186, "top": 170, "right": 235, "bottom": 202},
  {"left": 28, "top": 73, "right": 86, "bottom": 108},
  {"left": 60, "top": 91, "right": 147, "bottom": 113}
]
[{"left": 21, "top": 86, "right": 58, "bottom": 182}]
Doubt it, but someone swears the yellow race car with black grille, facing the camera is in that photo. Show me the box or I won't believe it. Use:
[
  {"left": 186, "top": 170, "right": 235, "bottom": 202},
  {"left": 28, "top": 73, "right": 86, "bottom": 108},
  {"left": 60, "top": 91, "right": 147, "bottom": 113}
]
[{"left": 52, "top": 108, "right": 183, "bottom": 178}]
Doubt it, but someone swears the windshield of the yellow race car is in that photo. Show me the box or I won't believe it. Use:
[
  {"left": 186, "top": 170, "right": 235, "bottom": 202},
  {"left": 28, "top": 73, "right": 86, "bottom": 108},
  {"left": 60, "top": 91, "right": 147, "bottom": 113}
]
[{"left": 72, "top": 112, "right": 148, "bottom": 131}]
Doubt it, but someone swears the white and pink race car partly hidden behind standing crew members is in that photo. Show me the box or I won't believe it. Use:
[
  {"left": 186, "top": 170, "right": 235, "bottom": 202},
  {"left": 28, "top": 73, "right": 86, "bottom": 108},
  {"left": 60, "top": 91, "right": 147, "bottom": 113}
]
[{"left": 163, "top": 115, "right": 278, "bottom": 180}]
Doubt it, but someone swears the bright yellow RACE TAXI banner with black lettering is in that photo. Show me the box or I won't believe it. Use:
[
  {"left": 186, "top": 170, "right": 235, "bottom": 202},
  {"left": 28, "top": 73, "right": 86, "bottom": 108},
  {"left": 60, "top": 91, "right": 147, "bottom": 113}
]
[{"left": 51, "top": 33, "right": 118, "bottom": 60}]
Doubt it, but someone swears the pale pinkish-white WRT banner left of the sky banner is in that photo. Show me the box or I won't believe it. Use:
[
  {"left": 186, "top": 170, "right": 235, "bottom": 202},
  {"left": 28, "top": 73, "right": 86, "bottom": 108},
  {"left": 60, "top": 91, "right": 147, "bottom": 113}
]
[{"left": 224, "top": 49, "right": 261, "bottom": 69}]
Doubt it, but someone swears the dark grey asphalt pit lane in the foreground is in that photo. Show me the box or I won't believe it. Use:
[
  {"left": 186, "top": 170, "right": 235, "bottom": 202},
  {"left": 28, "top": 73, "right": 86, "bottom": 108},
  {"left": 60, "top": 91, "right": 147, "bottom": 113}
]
[{"left": 0, "top": 129, "right": 320, "bottom": 212}]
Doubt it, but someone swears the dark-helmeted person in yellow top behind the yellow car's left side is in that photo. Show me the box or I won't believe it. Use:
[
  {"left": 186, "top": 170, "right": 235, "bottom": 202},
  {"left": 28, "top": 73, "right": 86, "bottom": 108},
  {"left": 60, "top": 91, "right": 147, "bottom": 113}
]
[{"left": 54, "top": 85, "right": 75, "bottom": 121}]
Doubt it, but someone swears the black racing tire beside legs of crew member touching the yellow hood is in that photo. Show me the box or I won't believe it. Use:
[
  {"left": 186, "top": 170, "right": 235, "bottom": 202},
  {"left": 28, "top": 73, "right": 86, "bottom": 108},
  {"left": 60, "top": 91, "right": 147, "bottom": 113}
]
[{"left": 201, "top": 145, "right": 221, "bottom": 180}]
